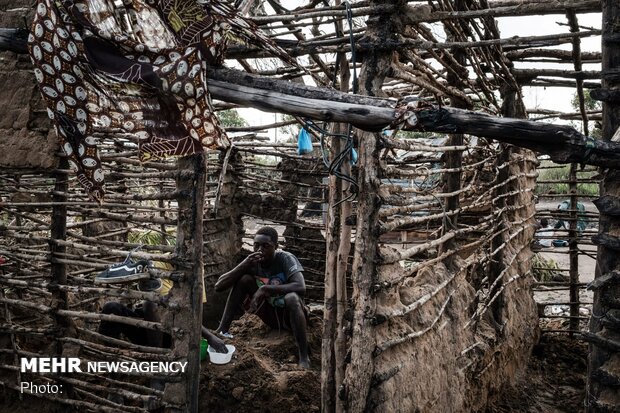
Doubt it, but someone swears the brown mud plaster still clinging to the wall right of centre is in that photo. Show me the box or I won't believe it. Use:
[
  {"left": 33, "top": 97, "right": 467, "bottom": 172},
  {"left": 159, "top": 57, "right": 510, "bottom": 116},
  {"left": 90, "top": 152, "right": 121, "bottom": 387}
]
[{"left": 369, "top": 151, "right": 538, "bottom": 412}]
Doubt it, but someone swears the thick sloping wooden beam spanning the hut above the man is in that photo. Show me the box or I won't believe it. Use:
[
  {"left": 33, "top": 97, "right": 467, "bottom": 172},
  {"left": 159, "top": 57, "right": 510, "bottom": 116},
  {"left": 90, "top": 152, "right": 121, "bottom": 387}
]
[{"left": 2, "top": 27, "right": 620, "bottom": 168}]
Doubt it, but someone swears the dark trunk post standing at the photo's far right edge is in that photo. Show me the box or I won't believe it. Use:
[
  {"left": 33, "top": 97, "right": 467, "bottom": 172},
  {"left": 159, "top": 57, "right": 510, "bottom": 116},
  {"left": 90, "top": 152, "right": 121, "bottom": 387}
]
[{"left": 585, "top": 0, "right": 620, "bottom": 413}]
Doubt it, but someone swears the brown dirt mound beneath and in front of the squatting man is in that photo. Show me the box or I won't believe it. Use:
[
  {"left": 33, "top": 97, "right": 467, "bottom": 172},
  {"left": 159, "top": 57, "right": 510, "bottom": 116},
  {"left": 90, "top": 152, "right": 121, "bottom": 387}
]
[{"left": 200, "top": 313, "right": 322, "bottom": 413}]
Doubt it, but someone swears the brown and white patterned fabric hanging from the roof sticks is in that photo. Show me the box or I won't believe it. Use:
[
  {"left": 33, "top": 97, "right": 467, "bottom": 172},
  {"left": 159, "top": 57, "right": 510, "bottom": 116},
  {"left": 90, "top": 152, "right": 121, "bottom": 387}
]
[{"left": 28, "top": 0, "right": 296, "bottom": 201}]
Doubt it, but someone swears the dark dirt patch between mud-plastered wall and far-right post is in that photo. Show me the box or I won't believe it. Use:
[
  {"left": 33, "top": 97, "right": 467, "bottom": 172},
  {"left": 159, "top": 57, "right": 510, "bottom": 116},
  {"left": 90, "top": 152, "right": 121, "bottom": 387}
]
[{"left": 486, "top": 334, "right": 588, "bottom": 413}]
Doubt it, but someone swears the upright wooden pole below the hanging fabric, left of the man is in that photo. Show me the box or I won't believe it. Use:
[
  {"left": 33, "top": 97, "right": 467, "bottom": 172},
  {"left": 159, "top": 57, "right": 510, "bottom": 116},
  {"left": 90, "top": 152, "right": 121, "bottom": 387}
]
[{"left": 163, "top": 152, "right": 206, "bottom": 413}]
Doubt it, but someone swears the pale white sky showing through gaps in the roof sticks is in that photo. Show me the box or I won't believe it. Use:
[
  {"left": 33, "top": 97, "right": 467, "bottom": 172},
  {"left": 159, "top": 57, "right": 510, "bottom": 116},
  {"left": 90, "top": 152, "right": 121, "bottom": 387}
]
[{"left": 231, "top": 0, "right": 601, "bottom": 140}]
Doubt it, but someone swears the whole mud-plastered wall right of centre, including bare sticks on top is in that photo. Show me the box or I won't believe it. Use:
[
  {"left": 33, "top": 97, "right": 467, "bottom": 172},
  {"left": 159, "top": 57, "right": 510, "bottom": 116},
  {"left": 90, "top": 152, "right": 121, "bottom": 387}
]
[{"left": 347, "top": 136, "right": 539, "bottom": 412}]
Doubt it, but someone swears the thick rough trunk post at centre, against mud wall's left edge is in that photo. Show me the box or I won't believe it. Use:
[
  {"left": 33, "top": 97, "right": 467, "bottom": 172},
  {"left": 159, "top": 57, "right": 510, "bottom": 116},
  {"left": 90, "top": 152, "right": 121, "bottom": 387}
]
[{"left": 344, "top": 0, "right": 406, "bottom": 413}]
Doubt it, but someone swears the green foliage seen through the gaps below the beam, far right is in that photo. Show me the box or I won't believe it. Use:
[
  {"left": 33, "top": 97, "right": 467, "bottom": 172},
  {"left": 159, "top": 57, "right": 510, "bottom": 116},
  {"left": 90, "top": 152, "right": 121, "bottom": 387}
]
[{"left": 536, "top": 161, "right": 599, "bottom": 196}]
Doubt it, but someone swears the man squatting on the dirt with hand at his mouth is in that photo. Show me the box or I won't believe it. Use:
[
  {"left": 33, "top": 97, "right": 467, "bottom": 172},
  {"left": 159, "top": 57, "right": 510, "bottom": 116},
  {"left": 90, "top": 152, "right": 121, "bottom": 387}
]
[{"left": 215, "top": 227, "right": 310, "bottom": 368}]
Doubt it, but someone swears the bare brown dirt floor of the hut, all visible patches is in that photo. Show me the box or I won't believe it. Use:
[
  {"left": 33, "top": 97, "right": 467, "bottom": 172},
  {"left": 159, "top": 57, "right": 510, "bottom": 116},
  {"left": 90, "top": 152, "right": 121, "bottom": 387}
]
[{"left": 0, "top": 313, "right": 587, "bottom": 413}]
